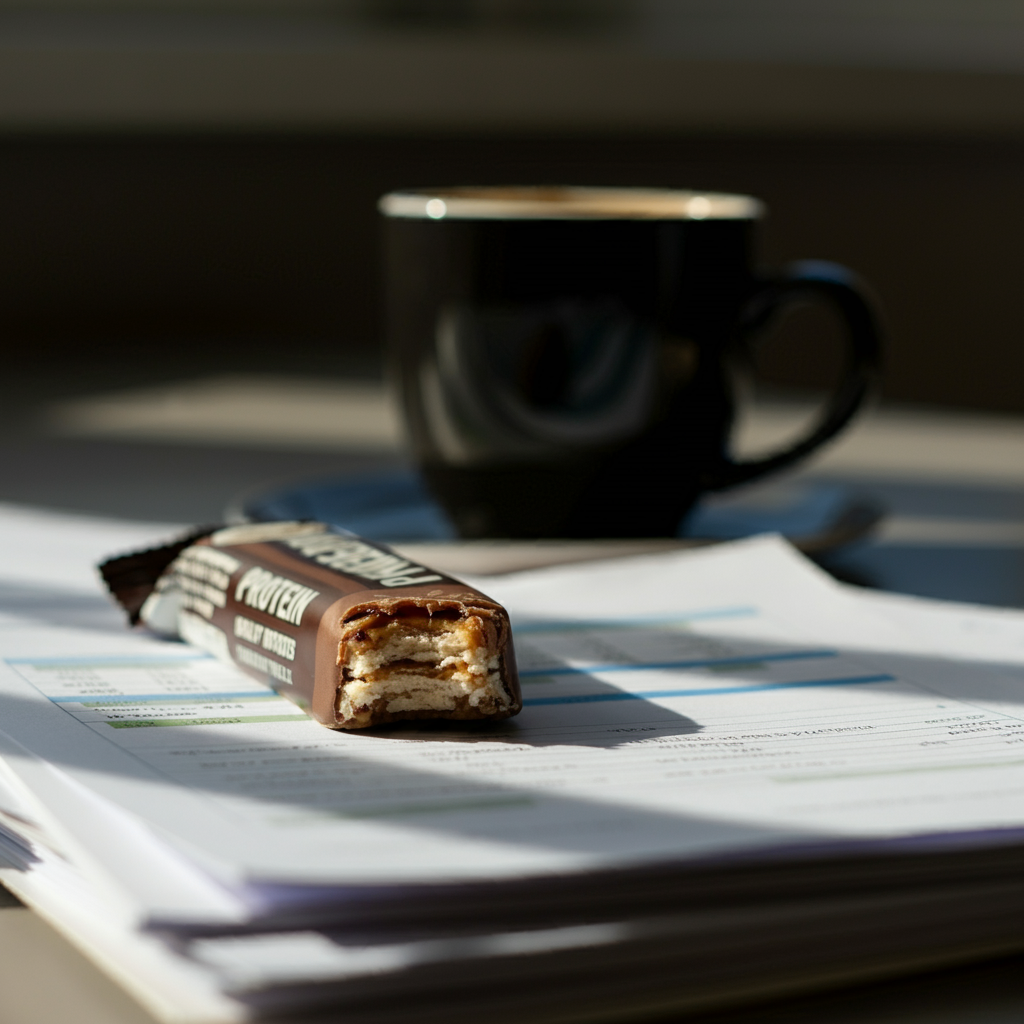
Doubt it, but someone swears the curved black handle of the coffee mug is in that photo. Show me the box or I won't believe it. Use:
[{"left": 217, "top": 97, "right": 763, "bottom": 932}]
[{"left": 706, "top": 260, "right": 882, "bottom": 490}]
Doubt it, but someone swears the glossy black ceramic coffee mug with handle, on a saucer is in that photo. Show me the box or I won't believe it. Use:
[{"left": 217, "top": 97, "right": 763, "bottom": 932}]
[{"left": 380, "top": 187, "right": 880, "bottom": 538}]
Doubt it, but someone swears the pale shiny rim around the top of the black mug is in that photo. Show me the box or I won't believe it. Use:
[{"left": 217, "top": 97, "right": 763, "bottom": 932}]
[{"left": 377, "top": 185, "right": 764, "bottom": 220}]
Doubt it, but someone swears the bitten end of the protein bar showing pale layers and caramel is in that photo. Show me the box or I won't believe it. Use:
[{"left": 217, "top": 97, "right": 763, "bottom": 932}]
[{"left": 337, "top": 609, "right": 511, "bottom": 729}]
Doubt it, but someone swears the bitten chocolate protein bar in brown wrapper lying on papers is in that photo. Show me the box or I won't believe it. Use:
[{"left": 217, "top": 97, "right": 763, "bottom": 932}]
[{"left": 100, "top": 523, "right": 521, "bottom": 729}]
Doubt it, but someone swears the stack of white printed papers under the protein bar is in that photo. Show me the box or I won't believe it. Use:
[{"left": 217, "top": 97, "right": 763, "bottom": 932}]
[{"left": 0, "top": 508, "right": 1024, "bottom": 1024}]
